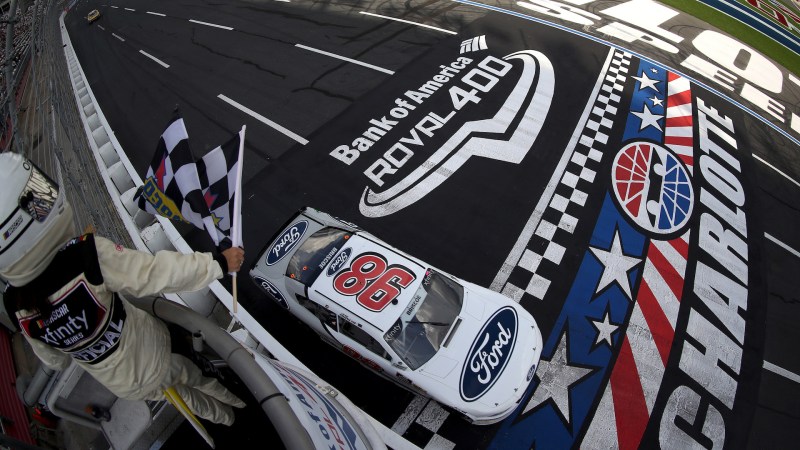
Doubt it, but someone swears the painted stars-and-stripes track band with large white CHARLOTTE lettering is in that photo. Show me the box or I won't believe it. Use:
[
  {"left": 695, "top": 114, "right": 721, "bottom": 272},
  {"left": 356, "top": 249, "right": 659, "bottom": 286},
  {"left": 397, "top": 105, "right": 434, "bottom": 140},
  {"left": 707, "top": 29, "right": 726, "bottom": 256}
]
[{"left": 489, "top": 56, "right": 764, "bottom": 449}]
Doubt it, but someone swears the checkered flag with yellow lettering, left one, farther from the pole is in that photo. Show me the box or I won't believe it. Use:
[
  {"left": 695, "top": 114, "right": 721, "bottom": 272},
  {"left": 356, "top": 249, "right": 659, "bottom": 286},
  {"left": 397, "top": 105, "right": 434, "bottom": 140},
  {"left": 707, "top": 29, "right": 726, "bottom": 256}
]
[{"left": 134, "top": 113, "right": 219, "bottom": 245}]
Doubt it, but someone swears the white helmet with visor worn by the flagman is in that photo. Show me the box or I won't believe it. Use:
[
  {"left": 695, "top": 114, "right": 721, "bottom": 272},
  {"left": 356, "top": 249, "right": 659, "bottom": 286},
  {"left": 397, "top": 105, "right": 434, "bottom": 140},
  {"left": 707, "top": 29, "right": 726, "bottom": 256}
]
[{"left": 0, "top": 152, "right": 75, "bottom": 286}]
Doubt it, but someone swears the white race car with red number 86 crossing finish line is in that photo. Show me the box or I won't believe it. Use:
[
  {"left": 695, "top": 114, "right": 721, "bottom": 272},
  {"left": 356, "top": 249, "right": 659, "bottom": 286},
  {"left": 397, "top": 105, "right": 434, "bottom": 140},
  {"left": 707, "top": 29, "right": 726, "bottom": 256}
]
[{"left": 250, "top": 208, "right": 542, "bottom": 425}]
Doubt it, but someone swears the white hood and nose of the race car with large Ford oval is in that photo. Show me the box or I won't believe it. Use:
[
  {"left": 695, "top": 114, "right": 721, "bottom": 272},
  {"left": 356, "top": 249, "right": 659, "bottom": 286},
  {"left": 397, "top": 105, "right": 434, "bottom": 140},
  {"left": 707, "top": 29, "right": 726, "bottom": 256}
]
[{"left": 417, "top": 288, "right": 542, "bottom": 418}]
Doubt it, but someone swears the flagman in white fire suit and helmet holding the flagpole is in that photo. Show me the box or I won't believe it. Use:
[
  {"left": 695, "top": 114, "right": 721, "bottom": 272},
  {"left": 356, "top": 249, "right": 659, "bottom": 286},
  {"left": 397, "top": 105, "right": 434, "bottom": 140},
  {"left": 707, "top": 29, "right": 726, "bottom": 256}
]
[{"left": 0, "top": 153, "right": 245, "bottom": 425}]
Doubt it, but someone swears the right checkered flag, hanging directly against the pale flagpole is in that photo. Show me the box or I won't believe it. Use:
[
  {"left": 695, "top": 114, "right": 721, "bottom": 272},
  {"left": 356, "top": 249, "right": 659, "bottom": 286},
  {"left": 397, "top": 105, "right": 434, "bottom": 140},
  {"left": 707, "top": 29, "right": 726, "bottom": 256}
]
[{"left": 197, "top": 132, "right": 243, "bottom": 246}]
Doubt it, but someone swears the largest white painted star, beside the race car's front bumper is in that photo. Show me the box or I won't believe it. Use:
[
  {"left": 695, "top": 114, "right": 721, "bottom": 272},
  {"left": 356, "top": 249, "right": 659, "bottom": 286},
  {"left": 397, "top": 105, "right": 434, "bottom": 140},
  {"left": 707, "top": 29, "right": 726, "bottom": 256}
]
[{"left": 522, "top": 332, "right": 592, "bottom": 423}]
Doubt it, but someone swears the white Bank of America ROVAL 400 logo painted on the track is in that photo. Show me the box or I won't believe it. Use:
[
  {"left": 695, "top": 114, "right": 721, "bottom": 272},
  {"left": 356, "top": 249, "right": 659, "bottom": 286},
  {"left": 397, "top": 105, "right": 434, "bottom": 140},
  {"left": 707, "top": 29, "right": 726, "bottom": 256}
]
[{"left": 330, "top": 38, "right": 555, "bottom": 217}]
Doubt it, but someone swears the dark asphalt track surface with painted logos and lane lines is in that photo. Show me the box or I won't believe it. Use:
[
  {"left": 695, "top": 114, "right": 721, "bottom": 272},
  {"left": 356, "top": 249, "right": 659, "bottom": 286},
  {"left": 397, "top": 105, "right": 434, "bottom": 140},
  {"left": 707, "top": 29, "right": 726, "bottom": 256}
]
[{"left": 66, "top": 0, "right": 800, "bottom": 448}]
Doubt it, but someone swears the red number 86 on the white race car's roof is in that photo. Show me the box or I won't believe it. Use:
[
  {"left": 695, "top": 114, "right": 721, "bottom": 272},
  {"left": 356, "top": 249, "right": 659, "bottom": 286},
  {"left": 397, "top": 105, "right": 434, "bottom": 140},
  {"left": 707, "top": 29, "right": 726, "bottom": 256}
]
[{"left": 333, "top": 253, "right": 417, "bottom": 312}]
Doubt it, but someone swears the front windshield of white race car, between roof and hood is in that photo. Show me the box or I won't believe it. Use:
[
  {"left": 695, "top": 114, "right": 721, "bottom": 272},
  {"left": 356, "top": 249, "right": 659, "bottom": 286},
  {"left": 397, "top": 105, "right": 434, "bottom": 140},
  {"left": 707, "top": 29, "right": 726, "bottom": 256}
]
[{"left": 383, "top": 269, "right": 464, "bottom": 369}]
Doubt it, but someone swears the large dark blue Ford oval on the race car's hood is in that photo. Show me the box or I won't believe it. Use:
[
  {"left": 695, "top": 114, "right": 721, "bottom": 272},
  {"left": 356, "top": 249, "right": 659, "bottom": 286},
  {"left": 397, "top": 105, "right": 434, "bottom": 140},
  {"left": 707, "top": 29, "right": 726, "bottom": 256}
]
[{"left": 459, "top": 306, "right": 518, "bottom": 402}]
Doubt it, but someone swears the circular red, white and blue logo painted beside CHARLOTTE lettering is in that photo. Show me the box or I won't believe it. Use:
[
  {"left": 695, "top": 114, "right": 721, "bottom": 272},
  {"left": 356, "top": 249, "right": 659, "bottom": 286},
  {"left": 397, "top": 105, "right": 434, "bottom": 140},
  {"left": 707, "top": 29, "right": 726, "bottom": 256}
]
[{"left": 611, "top": 142, "right": 694, "bottom": 235}]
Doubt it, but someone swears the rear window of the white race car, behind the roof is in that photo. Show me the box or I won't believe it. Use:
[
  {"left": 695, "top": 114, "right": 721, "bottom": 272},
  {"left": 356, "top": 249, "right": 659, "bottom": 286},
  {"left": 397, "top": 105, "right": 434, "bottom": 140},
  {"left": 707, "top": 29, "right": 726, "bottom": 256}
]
[{"left": 286, "top": 227, "right": 352, "bottom": 286}]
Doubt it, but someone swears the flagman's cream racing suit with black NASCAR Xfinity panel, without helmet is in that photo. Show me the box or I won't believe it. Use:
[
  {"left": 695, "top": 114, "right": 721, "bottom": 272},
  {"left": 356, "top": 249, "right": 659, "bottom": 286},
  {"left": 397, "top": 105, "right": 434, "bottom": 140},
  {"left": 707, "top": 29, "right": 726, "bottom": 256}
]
[{"left": 13, "top": 234, "right": 244, "bottom": 425}]
